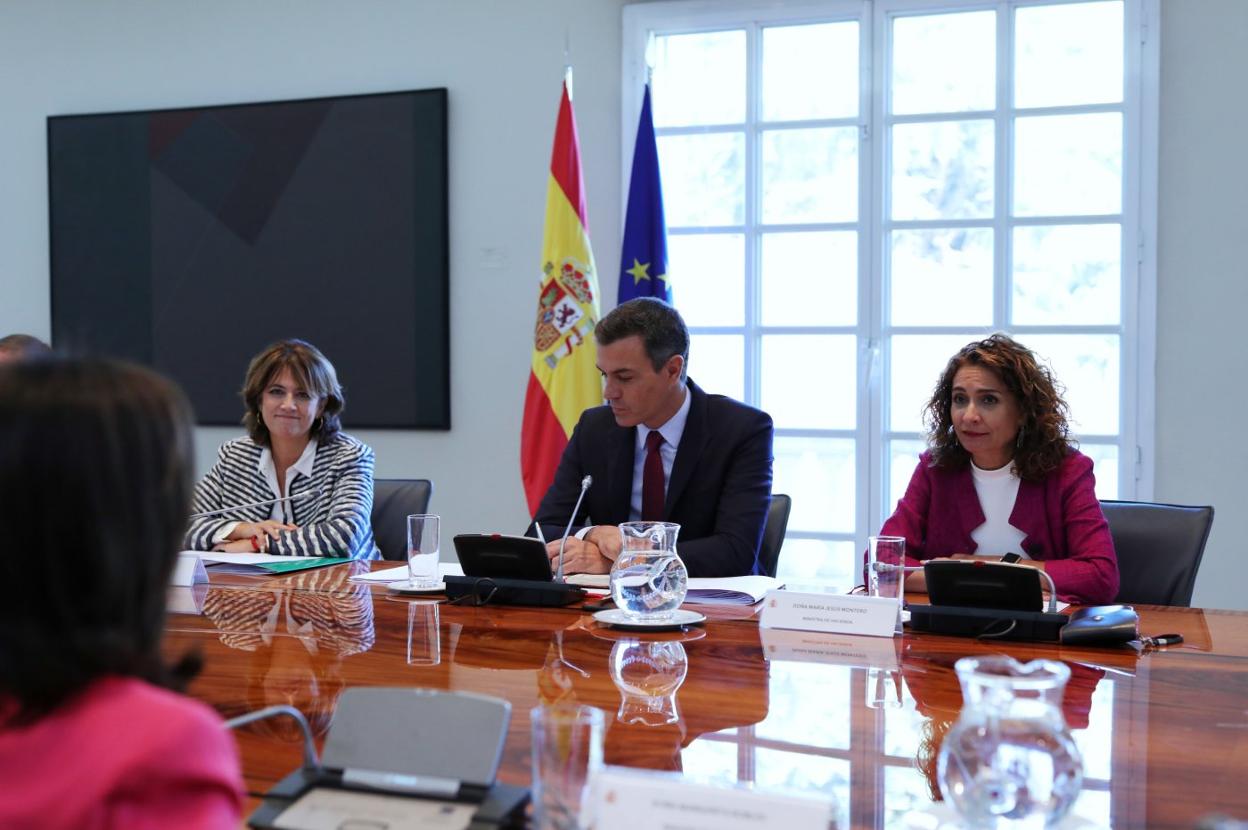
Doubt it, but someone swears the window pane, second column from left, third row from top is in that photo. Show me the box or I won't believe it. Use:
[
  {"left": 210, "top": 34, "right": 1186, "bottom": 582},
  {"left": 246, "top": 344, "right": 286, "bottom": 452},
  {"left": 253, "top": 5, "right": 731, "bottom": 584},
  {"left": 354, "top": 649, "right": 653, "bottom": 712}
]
[{"left": 760, "top": 231, "right": 857, "bottom": 326}]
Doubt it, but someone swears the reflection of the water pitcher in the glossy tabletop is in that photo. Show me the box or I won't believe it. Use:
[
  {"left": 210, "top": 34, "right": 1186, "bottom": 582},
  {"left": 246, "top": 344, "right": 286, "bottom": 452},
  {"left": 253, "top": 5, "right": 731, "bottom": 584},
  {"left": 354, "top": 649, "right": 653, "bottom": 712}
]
[{"left": 608, "top": 639, "right": 689, "bottom": 726}]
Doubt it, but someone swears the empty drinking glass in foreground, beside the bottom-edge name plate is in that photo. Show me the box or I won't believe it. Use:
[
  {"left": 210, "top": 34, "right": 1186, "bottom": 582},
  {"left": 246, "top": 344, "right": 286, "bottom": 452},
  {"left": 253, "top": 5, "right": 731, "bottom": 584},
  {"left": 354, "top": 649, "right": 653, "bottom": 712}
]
[{"left": 529, "top": 704, "right": 603, "bottom": 830}]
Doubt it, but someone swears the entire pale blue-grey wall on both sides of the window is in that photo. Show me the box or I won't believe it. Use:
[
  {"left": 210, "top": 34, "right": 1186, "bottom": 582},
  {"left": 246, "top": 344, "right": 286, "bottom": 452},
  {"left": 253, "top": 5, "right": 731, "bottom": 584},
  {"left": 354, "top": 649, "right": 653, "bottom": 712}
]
[{"left": 0, "top": 0, "right": 1248, "bottom": 608}]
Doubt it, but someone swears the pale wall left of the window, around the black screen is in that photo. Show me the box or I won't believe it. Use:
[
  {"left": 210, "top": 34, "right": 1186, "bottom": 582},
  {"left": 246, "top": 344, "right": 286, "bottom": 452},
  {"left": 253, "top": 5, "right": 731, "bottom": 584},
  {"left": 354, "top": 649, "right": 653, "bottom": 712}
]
[{"left": 0, "top": 0, "right": 622, "bottom": 548}]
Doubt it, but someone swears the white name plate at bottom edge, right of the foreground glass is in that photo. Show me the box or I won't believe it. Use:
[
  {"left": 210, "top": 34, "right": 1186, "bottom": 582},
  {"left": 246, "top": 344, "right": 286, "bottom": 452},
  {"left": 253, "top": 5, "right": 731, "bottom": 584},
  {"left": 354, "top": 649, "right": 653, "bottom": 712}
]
[{"left": 589, "top": 768, "right": 834, "bottom": 830}]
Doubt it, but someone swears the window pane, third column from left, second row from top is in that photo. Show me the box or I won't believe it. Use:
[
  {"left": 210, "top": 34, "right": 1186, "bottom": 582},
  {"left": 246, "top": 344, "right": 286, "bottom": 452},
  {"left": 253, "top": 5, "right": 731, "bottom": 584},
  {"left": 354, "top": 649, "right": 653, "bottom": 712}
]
[{"left": 888, "top": 121, "right": 993, "bottom": 220}]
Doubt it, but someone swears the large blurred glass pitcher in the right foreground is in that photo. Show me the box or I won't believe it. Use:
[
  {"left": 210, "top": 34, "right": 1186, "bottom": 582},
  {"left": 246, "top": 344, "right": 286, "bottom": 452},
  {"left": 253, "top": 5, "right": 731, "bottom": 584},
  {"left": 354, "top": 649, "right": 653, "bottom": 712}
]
[{"left": 936, "top": 657, "right": 1083, "bottom": 828}]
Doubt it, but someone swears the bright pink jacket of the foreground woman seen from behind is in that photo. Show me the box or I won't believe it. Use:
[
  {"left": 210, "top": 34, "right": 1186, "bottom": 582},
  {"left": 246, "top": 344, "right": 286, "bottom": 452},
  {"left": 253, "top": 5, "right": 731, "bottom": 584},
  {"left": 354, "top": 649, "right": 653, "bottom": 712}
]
[{"left": 0, "top": 678, "right": 243, "bottom": 830}]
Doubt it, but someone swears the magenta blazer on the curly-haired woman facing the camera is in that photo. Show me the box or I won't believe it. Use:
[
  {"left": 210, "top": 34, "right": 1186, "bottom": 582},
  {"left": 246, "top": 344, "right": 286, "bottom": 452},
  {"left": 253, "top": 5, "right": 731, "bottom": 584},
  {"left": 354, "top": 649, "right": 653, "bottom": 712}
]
[{"left": 880, "top": 449, "right": 1118, "bottom": 605}]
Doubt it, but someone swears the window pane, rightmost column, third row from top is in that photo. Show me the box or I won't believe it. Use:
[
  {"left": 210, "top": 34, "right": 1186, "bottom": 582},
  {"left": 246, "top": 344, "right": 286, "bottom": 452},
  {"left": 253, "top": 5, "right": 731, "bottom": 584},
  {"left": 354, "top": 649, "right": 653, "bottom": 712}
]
[{"left": 1012, "top": 225, "right": 1122, "bottom": 326}]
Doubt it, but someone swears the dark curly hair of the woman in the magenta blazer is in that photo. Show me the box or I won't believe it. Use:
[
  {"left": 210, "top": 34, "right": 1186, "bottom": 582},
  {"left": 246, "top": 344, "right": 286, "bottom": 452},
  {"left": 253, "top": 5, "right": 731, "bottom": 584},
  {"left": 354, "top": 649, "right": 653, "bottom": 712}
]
[{"left": 924, "top": 332, "right": 1075, "bottom": 482}]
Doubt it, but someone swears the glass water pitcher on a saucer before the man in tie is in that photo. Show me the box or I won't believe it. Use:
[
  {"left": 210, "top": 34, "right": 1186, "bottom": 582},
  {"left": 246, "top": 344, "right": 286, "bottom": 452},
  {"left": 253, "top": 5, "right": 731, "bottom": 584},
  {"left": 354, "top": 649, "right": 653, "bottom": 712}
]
[{"left": 610, "top": 522, "right": 689, "bottom": 623}]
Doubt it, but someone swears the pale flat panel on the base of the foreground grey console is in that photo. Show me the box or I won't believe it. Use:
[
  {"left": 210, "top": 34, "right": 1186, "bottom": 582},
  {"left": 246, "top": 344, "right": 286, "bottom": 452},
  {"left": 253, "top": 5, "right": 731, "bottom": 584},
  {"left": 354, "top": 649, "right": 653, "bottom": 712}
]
[{"left": 273, "top": 788, "right": 477, "bottom": 830}]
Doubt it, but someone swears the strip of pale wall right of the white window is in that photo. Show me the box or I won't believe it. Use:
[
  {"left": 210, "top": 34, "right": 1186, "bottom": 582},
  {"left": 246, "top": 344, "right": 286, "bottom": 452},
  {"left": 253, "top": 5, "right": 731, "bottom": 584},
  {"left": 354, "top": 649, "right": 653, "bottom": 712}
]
[{"left": 1154, "top": 0, "right": 1248, "bottom": 609}]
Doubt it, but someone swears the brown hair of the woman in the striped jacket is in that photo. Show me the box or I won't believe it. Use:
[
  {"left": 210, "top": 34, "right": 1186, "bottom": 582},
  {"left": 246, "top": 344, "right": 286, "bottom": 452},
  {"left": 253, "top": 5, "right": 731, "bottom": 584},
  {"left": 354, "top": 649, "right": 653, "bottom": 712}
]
[{"left": 240, "top": 339, "right": 346, "bottom": 447}]
